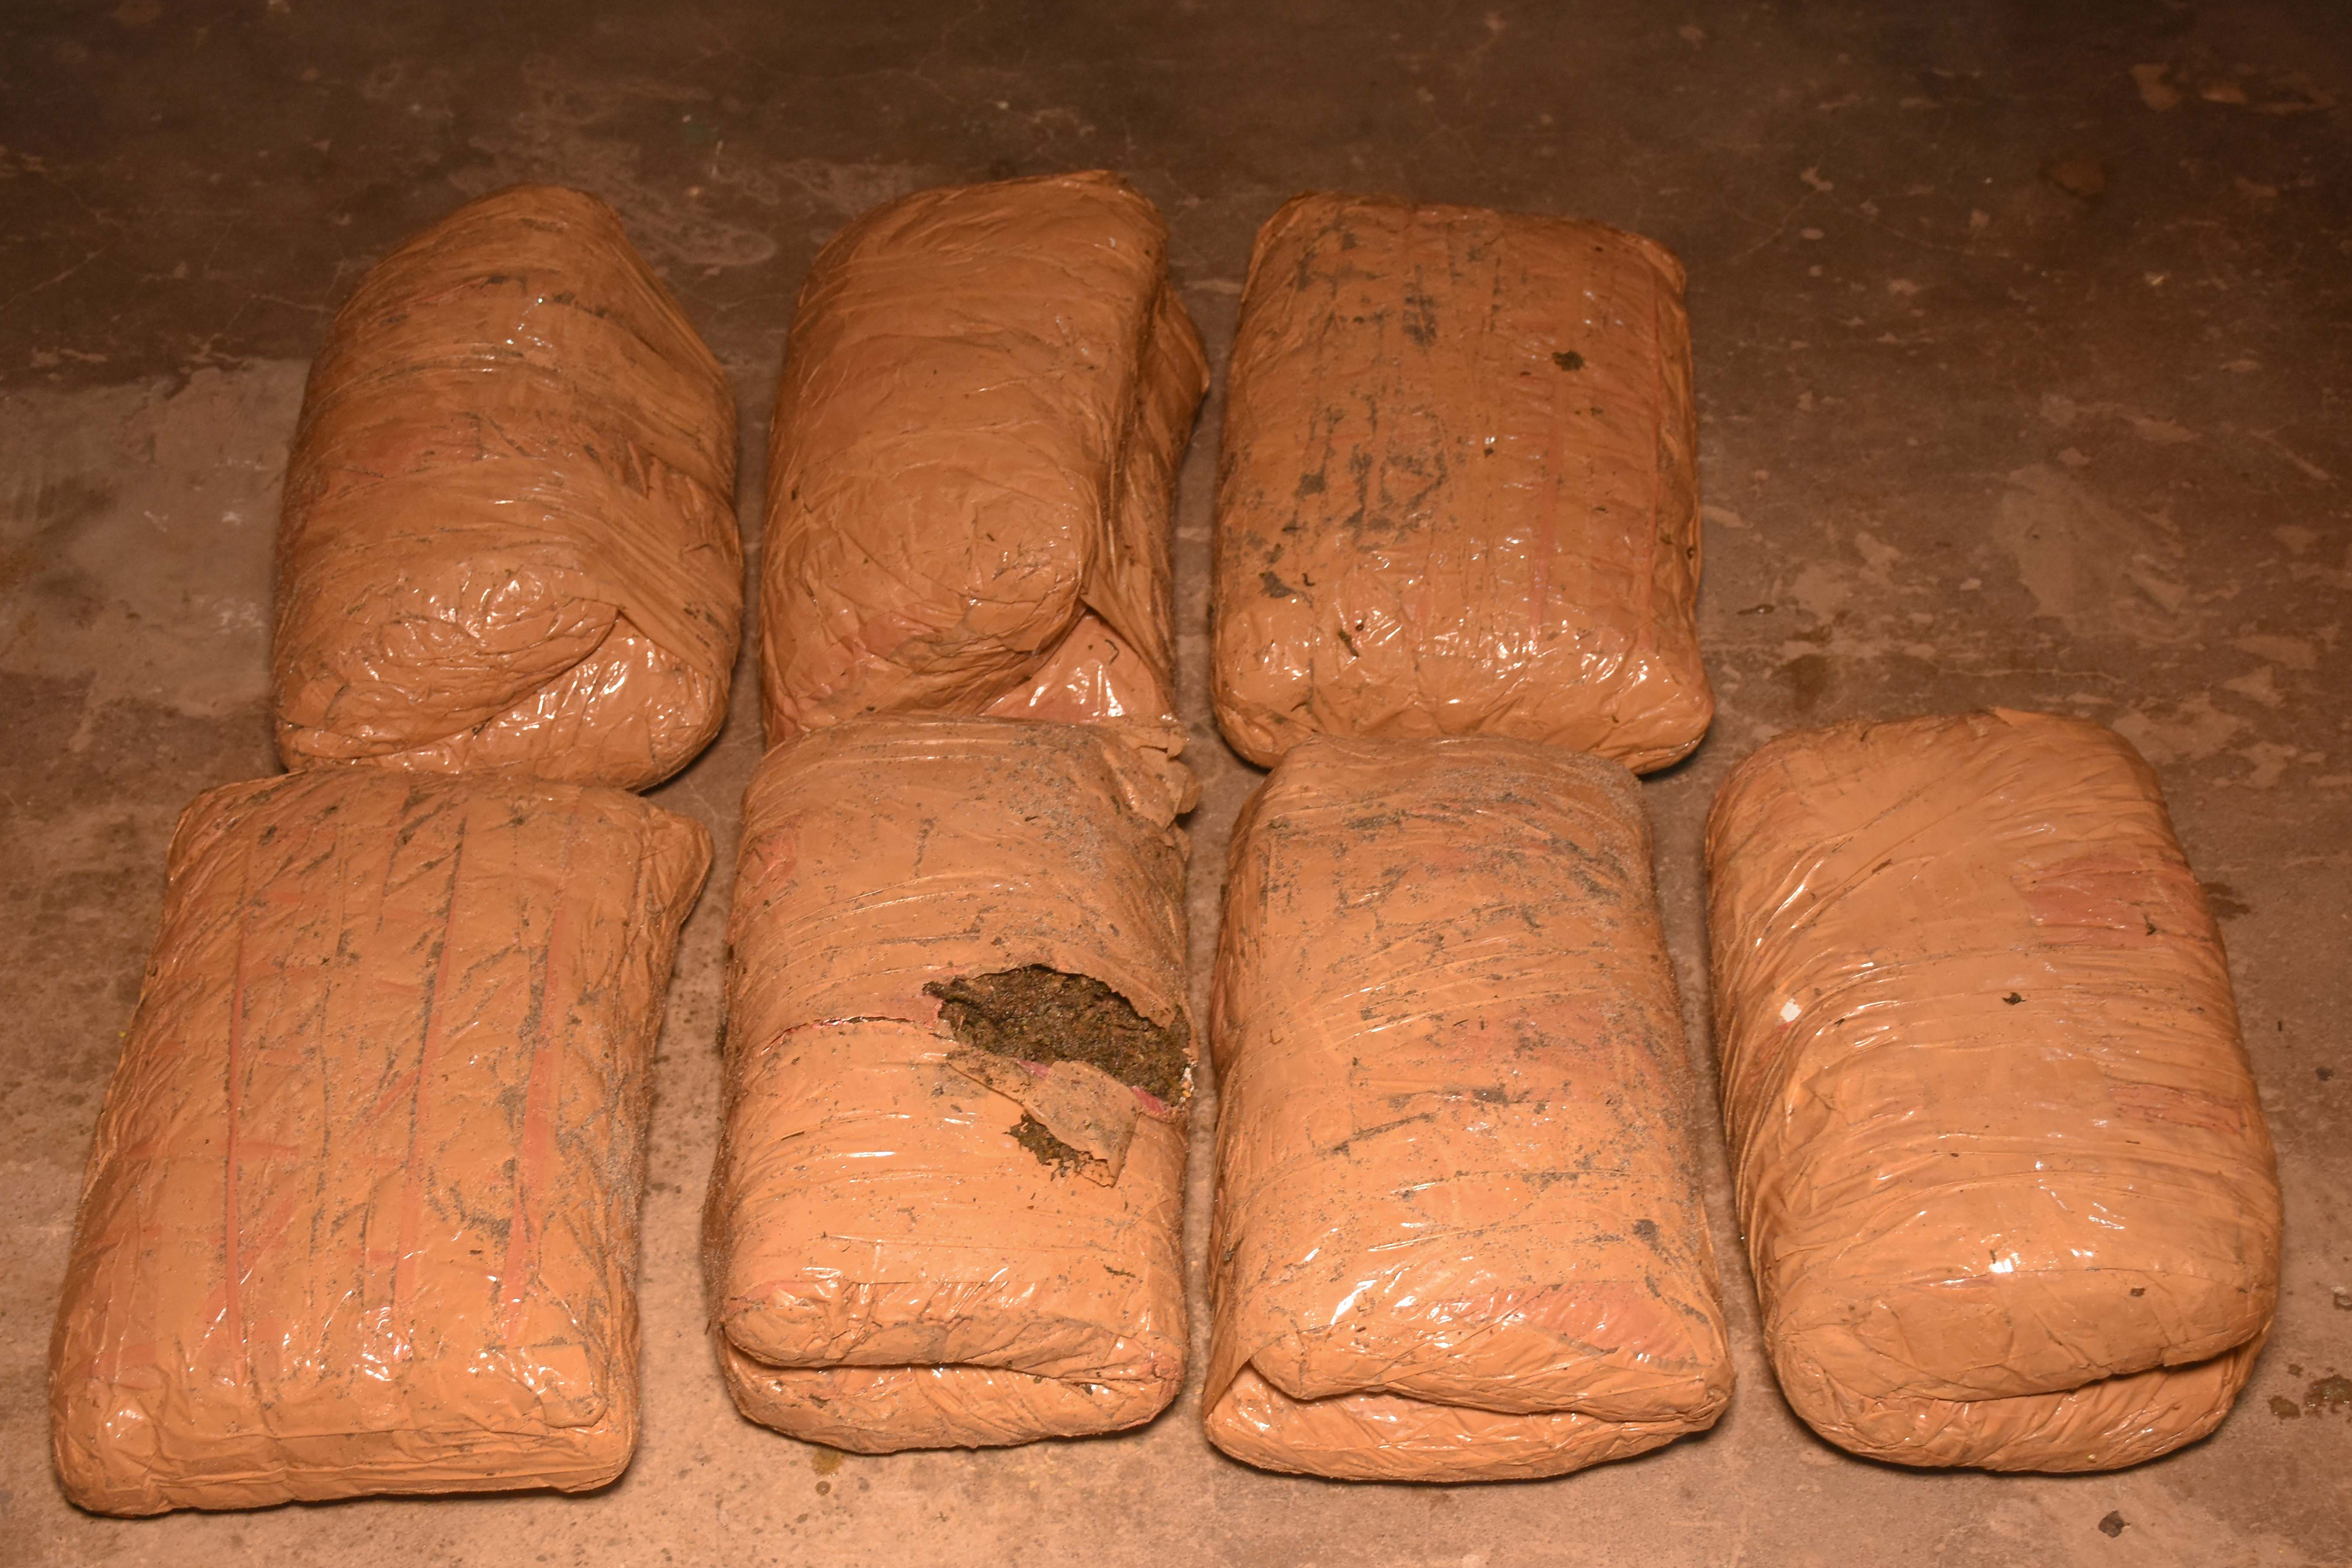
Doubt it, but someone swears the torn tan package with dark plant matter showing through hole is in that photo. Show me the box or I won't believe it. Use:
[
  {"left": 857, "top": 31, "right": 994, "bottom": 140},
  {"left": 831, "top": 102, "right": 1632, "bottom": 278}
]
[{"left": 703, "top": 715, "right": 1193, "bottom": 1453}]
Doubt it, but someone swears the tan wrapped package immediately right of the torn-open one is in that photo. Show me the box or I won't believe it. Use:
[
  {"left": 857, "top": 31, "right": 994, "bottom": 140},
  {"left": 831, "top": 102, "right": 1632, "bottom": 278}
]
[{"left": 1202, "top": 736, "right": 1731, "bottom": 1481}]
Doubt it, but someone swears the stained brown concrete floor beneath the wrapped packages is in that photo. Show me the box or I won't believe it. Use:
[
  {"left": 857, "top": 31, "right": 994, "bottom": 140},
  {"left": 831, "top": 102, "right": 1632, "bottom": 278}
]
[{"left": 0, "top": 0, "right": 2352, "bottom": 1568}]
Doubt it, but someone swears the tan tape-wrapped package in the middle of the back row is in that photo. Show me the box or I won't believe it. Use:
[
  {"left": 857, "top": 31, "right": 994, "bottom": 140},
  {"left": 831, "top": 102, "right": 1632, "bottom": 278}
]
[{"left": 760, "top": 174, "right": 1209, "bottom": 745}]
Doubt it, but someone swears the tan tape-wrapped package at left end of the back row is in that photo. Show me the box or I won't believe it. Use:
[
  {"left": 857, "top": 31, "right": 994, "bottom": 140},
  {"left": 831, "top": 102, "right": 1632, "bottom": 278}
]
[{"left": 273, "top": 186, "right": 743, "bottom": 788}]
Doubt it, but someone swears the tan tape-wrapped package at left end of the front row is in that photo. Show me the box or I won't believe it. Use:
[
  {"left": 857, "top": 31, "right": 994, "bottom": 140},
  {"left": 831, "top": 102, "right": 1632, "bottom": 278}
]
[{"left": 50, "top": 766, "right": 710, "bottom": 1514}]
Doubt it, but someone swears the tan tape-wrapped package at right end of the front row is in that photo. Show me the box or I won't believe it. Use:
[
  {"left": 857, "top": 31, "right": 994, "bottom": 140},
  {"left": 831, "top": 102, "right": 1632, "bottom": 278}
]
[{"left": 1708, "top": 710, "right": 2279, "bottom": 1472}]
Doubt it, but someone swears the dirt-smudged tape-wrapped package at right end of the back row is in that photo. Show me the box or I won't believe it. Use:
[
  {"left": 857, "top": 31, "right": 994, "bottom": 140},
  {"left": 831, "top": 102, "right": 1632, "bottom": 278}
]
[{"left": 1213, "top": 195, "right": 1714, "bottom": 774}]
